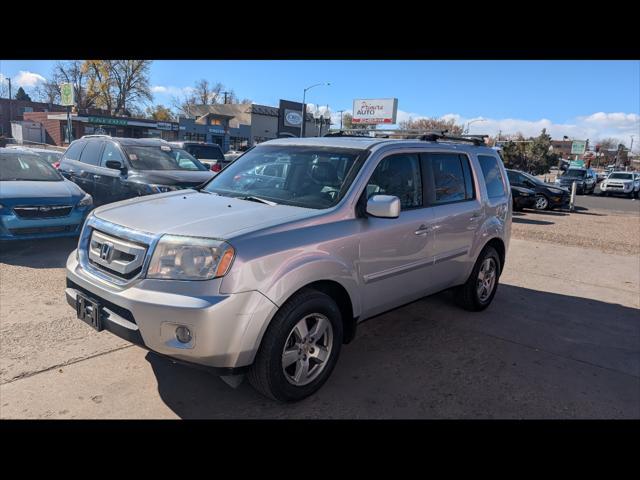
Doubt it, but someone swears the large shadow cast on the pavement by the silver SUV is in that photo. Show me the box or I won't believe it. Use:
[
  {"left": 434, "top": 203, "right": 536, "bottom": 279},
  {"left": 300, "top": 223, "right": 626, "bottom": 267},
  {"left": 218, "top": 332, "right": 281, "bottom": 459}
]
[{"left": 146, "top": 285, "right": 640, "bottom": 419}]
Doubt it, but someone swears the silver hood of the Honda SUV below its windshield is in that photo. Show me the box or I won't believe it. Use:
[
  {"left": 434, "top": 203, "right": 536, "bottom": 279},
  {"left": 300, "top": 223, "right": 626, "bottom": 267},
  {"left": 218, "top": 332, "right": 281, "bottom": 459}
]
[{"left": 94, "top": 190, "right": 321, "bottom": 239}]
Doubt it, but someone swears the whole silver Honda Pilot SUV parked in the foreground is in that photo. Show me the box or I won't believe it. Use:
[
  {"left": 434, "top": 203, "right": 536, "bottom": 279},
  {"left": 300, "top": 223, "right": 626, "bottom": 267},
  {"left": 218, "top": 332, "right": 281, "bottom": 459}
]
[{"left": 66, "top": 137, "right": 512, "bottom": 401}]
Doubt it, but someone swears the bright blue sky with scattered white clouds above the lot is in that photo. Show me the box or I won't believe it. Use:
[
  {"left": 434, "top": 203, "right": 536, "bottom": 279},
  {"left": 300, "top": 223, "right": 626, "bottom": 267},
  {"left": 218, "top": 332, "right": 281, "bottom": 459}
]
[{"left": 0, "top": 60, "right": 640, "bottom": 150}]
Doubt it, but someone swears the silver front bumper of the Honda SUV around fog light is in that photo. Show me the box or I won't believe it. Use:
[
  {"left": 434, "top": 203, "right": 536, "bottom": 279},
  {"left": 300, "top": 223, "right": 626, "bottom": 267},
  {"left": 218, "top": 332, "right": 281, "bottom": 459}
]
[{"left": 65, "top": 251, "right": 277, "bottom": 375}]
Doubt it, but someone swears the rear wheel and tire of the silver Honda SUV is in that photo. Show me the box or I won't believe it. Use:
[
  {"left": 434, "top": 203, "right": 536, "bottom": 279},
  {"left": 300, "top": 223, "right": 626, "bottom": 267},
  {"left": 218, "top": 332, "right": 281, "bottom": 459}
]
[{"left": 455, "top": 246, "right": 501, "bottom": 312}]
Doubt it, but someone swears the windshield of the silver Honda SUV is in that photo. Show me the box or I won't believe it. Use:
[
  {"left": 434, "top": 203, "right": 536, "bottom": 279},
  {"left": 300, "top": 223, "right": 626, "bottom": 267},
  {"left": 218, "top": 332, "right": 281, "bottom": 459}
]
[{"left": 204, "top": 145, "right": 363, "bottom": 208}]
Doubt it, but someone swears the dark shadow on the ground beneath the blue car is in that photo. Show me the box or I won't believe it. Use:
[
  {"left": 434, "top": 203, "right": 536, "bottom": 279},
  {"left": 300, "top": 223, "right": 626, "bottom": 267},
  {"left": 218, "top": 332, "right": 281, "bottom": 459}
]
[{"left": 0, "top": 237, "right": 78, "bottom": 268}]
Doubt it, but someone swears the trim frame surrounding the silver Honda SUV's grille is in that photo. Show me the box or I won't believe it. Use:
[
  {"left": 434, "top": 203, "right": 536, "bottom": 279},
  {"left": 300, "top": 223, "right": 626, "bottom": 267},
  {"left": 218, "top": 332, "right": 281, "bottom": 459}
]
[{"left": 78, "top": 215, "right": 160, "bottom": 287}]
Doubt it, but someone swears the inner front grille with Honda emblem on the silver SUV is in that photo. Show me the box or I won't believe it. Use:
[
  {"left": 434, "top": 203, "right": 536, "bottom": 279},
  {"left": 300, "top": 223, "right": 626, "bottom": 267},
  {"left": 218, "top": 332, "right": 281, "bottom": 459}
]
[{"left": 87, "top": 230, "right": 147, "bottom": 280}]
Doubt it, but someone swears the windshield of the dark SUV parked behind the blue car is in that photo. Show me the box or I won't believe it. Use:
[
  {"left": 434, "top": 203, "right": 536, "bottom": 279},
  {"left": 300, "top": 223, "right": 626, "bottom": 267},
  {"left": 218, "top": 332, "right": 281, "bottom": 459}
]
[{"left": 124, "top": 145, "right": 208, "bottom": 171}]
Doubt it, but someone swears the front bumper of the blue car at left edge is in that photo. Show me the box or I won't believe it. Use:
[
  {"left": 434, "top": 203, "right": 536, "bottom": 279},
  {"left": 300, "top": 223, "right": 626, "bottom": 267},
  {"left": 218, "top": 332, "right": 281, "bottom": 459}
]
[{"left": 0, "top": 207, "right": 89, "bottom": 240}]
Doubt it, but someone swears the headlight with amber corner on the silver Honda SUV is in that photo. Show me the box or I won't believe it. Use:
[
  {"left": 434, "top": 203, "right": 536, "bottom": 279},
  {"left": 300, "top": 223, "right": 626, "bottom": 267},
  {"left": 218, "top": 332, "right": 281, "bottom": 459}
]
[{"left": 147, "top": 235, "right": 235, "bottom": 280}]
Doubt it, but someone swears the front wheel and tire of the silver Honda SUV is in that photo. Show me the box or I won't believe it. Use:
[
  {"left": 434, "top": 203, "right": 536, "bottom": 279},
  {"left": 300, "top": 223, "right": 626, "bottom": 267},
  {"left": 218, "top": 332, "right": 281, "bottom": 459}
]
[{"left": 247, "top": 289, "right": 343, "bottom": 402}]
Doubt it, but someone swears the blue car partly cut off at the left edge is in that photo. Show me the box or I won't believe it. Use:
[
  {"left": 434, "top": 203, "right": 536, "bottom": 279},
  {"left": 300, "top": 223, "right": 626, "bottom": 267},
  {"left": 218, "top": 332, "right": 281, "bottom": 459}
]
[{"left": 0, "top": 148, "right": 93, "bottom": 240}]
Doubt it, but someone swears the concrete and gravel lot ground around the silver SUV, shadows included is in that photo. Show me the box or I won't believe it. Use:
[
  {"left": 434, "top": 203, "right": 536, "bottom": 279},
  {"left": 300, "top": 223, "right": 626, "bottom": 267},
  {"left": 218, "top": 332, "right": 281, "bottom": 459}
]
[{"left": 0, "top": 196, "right": 640, "bottom": 418}]
